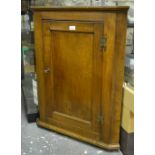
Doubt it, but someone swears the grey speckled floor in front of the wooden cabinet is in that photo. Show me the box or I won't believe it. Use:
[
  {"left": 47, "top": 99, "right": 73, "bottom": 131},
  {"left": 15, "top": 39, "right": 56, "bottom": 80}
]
[{"left": 21, "top": 95, "right": 122, "bottom": 155}]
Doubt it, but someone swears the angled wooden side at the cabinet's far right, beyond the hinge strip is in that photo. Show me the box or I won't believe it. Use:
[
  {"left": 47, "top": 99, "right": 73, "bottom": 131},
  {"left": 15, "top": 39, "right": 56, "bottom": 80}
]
[{"left": 110, "top": 13, "right": 127, "bottom": 144}]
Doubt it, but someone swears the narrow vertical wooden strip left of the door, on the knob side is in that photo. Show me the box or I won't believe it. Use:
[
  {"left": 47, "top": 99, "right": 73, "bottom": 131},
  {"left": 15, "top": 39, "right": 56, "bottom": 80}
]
[{"left": 34, "top": 12, "right": 45, "bottom": 120}]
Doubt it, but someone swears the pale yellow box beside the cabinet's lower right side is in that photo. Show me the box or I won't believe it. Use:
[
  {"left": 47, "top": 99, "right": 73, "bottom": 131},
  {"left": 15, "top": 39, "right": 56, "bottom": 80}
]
[{"left": 121, "top": 84, "right": 134, "bottom": 133}]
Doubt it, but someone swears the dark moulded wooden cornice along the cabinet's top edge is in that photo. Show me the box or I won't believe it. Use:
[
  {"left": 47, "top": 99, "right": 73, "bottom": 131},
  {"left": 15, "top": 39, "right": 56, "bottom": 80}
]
[{"left": 31, "top": 6, "right": 129, "bottom": 12}]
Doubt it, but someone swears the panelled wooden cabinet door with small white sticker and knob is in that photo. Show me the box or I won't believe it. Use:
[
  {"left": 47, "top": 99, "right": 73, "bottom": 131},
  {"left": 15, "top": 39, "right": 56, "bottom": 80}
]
[{"left": 42, "top": 20, "right": 104, "bottom": 140}]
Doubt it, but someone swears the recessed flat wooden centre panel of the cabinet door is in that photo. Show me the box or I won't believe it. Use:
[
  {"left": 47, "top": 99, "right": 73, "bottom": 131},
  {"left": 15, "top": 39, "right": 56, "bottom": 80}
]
[{"left": 51, "top": 32, "right": 93, "bottom": 121}]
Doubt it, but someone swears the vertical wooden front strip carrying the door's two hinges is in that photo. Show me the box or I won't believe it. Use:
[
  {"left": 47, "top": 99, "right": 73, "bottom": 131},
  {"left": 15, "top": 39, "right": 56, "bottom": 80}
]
[{"left": 101, "top": 14, "right": 116, "bottom": 144}]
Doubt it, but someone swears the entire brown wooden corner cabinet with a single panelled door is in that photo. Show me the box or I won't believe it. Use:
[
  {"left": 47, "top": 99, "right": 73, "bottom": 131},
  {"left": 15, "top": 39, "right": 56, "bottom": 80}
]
[{"left": 32, "top": 6, "right": 128, "bottom": 150}]
